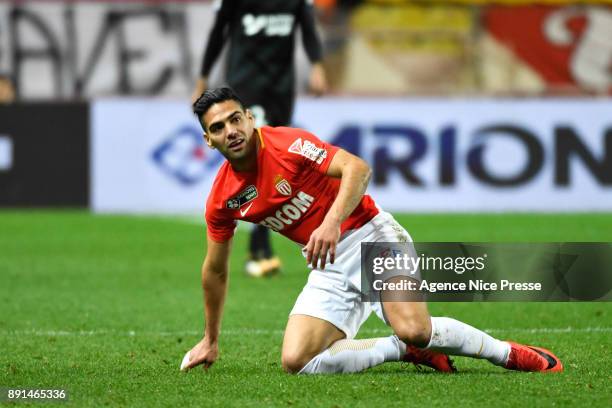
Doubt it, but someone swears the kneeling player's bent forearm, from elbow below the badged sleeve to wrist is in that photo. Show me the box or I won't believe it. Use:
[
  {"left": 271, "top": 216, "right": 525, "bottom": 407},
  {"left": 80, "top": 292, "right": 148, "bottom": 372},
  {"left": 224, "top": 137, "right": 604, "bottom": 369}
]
[{"left": 325, "top": 159, "right": 372, "bottom": 225}]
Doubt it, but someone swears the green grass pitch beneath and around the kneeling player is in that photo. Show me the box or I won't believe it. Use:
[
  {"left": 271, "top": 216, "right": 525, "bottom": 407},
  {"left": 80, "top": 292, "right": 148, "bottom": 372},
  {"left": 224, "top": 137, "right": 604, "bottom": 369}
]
[{"left": 0, "top": 211, "right": 612, "bottom": 407}]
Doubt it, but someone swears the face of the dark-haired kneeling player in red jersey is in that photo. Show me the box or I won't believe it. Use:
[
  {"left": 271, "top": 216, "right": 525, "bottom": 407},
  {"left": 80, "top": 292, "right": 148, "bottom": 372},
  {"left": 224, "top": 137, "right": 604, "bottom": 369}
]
[{"left": 203, "top": 101, "right": 256, "bottom": 161}]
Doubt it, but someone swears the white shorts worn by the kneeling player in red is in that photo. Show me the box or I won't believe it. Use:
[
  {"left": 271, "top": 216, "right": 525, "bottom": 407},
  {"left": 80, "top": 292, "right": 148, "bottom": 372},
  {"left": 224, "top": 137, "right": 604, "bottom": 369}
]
[{"left": 290, "top": 211, "right": 412, "bottom": 339}]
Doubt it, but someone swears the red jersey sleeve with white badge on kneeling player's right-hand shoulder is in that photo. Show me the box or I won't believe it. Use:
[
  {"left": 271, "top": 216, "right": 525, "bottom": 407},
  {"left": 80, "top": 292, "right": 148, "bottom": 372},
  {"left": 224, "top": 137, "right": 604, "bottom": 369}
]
[{"left": 278, "top": 128, "right": 340, "bottom": 174}]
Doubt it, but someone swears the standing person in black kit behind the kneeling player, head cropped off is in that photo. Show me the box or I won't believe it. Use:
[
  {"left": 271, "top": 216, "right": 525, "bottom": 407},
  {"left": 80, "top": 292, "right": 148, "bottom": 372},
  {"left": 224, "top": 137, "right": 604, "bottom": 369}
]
[{"left": 192, "top": 0, "right": 327, "bottom": 276}]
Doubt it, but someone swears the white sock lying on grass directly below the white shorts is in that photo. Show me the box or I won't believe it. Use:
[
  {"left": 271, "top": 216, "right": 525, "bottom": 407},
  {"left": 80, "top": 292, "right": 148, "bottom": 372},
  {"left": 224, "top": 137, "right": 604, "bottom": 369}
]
[{"left": 298, "top": 336, "right": 406, "bottom": 374}]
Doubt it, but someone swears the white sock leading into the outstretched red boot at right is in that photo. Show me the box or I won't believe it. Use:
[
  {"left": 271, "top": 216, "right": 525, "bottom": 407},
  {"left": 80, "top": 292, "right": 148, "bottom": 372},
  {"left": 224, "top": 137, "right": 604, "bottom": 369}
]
[{"left": 426, "top": 317, "right": 510, "bottom": 366}]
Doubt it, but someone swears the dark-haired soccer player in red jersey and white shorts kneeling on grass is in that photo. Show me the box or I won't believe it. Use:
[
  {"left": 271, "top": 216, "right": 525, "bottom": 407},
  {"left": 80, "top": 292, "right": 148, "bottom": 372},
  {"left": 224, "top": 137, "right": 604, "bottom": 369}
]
[{"left": 181, "top": 88, "right": 563, "bottom": 374}]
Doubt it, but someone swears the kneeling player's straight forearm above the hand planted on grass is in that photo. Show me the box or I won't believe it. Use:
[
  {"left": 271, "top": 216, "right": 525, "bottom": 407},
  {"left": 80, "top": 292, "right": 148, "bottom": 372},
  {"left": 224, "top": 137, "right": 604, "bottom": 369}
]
[{"left": 202, "top": 262, "right": 227, "bottom": 343}]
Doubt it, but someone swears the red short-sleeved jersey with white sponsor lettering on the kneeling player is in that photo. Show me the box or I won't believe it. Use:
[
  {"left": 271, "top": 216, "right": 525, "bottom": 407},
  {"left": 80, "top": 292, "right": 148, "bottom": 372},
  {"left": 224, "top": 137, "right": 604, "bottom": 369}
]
[{"left": 206, "top": 126, "right": 378, "bottom": 245}]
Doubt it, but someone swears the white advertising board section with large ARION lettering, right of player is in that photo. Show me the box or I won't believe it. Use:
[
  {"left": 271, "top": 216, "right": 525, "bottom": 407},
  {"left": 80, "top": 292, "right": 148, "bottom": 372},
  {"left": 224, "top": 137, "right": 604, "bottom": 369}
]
[{"left": 294, "top": 99, "right": 612, "bottom": 212}]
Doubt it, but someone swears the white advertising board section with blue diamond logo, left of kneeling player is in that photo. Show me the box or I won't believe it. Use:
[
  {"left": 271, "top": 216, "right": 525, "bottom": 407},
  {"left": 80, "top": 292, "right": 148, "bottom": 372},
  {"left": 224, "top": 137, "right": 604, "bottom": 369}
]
[{"left": 91, "top": 99, "right": 223, "bottom": 214}]
